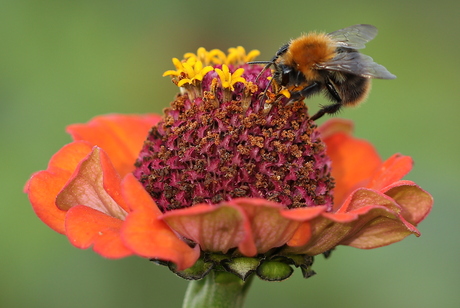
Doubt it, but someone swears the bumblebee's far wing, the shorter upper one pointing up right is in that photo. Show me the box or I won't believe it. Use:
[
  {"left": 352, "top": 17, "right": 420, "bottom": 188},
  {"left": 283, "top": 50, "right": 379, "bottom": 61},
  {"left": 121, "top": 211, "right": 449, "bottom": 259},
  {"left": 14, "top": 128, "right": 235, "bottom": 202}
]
[{"left": 328, "top": 24, "right": 377, "bottom": 49}]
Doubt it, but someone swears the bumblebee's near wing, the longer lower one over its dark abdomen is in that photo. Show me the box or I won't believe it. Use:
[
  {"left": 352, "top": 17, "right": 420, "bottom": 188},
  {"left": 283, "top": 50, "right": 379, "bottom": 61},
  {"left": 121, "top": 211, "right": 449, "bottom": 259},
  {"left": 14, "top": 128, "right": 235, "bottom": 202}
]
[{"left": 316, "top": 52, "right": 396, "bottom": 79}]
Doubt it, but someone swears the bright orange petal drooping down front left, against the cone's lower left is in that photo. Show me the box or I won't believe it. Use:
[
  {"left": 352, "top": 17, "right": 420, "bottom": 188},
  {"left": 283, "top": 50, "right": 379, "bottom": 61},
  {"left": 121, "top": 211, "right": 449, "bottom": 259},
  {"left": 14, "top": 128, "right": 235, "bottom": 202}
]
[{"left": 122, "top": 174, "right": 200, "bottom": 270}]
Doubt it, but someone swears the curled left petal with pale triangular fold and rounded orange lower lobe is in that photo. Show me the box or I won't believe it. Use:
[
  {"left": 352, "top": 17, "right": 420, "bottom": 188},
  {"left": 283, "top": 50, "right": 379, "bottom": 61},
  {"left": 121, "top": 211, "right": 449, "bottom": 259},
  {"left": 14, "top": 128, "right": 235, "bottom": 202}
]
[{"left": 51, "top": 147, "right": 132, "bottom": 258}]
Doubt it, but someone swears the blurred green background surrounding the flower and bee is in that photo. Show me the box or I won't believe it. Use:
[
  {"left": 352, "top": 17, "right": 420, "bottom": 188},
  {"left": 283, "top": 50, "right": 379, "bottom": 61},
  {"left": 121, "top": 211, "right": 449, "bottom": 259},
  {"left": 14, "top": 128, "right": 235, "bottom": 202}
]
[{"left": 0, "top": 0, "right": 460, "bottom": 308}]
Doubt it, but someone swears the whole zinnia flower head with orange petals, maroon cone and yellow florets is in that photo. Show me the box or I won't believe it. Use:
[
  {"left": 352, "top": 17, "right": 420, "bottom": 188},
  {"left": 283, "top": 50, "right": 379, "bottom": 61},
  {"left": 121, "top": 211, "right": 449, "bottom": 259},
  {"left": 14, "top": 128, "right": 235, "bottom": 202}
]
[{"left": 25, "top": 47, "right": 433, "bottom": 280}]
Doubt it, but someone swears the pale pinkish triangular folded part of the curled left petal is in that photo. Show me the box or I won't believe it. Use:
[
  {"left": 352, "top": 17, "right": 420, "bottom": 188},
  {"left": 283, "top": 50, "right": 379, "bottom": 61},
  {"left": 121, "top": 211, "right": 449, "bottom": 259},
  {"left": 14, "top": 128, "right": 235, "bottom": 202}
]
[{"left": 56, "top": 147, "right": 126, "bottom": 220}]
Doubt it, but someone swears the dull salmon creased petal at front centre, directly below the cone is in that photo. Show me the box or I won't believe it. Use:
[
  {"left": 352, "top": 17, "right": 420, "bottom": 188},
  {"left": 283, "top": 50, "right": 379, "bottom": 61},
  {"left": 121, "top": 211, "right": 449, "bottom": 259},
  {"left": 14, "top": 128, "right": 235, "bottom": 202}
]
[{"left": 163, "top": 198, "right": 310, "bottom": 256}]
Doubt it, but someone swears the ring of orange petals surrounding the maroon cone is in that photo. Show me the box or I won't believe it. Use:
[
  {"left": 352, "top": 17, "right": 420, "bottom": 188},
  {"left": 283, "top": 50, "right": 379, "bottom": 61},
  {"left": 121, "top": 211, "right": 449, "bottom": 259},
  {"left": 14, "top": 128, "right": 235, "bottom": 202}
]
[{"left": 26, "top": 115, "right": 432, "bottom": 269}]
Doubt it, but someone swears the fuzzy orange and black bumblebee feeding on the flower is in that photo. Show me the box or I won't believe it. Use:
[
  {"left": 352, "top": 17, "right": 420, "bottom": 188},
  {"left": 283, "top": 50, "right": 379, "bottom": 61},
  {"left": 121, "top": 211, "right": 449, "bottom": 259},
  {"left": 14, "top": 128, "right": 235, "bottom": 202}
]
[{"left": 249, "top": 24, "right": 396, "bottom": 120}]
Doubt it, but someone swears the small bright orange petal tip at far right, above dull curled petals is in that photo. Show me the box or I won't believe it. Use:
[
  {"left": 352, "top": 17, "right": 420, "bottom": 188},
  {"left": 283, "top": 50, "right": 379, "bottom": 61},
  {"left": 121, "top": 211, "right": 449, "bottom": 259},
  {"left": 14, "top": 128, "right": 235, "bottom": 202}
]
[{"left": 366, "top": 154, "right": 413, "bottom": 190}]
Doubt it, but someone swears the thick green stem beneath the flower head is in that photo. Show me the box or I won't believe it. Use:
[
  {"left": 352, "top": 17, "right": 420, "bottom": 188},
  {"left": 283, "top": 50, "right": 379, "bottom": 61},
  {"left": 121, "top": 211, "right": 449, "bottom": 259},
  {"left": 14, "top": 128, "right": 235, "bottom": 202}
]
[{"left": 182, "top": 271, "right": 253, "bottom": 308}]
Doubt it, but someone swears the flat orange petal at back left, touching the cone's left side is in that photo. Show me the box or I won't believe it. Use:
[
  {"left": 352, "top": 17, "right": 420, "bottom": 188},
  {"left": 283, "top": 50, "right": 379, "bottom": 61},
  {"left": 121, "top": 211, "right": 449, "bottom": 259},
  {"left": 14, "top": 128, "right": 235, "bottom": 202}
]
[{"left": 67, "top": 115, "right": 161, "bottom": 176}]
